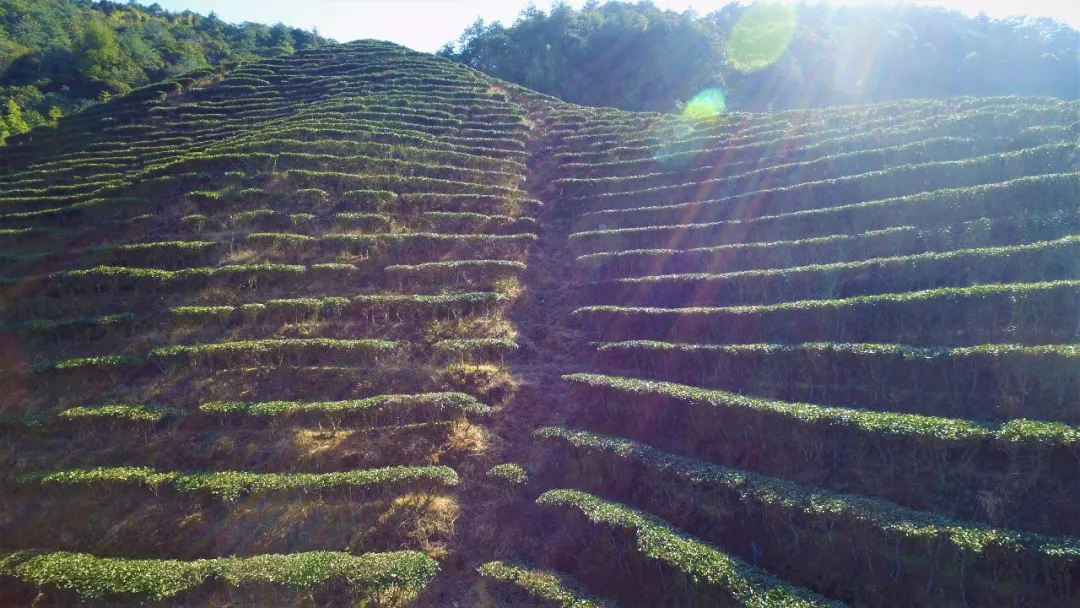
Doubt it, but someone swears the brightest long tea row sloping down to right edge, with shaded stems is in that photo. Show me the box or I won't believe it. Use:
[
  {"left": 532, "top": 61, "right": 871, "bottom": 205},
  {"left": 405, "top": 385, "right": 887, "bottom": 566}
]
[{"left": 564, "top": 374, "right": 1080, "bottom": 533}]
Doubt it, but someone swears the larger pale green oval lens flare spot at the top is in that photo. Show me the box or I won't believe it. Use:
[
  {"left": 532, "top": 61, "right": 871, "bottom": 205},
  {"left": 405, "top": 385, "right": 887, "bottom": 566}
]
[{"left": 727, "top": 2, "right": 797, "bottom": 72}]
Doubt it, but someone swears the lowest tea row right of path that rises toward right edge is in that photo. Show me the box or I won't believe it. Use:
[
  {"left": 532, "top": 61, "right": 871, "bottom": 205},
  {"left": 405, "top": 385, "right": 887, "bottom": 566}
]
[{"left": 573, "top": 281, "right": 1080, "bottom": 347}]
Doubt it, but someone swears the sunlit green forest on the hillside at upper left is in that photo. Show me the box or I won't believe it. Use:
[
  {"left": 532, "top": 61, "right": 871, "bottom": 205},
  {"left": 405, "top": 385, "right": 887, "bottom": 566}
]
[{"left": 0, "top": 0, "right": 329, "bottom": 136}]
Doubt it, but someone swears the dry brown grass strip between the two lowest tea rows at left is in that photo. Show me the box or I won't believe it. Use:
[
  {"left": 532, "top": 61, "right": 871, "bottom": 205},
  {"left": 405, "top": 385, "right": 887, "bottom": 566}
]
[{"left": 0, "top": 490, "right": 449, "bottom": 559}]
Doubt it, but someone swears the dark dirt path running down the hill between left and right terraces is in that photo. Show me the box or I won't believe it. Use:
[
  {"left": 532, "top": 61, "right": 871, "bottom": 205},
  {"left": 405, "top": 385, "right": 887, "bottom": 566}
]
[{"left": 418, "top": 93, "right": 585, "bottom": 608}]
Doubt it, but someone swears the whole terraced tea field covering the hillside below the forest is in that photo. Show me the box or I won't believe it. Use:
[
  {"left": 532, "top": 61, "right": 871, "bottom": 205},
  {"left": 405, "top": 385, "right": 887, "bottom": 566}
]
[{"left": 0, "top": 42, "right": 1080, "bottom": 607}]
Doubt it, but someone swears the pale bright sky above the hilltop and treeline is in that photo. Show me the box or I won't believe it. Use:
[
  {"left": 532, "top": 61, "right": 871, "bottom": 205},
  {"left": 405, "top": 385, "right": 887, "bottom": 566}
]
[{"left": 150, "top": 0, "right": 1080, "bottom": 52}]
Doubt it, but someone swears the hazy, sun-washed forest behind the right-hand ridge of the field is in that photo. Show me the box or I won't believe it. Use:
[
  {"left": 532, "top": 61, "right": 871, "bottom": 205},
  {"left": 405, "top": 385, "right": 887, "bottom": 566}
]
[{"left": 440, "top": 1, "right": 1080, "bottom": 111}]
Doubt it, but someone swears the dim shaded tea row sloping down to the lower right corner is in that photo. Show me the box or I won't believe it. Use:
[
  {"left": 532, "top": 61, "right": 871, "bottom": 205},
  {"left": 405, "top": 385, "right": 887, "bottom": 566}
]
[{"left": 536, "top": 428, "right": 1080, "bottom": 603}]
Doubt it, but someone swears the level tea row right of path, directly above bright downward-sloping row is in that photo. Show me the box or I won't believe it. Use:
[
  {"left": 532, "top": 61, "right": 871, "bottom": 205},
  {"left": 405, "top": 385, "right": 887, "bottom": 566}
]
[{"left": 598, "top": 341, "right": 1080, "bottom": 423}]
